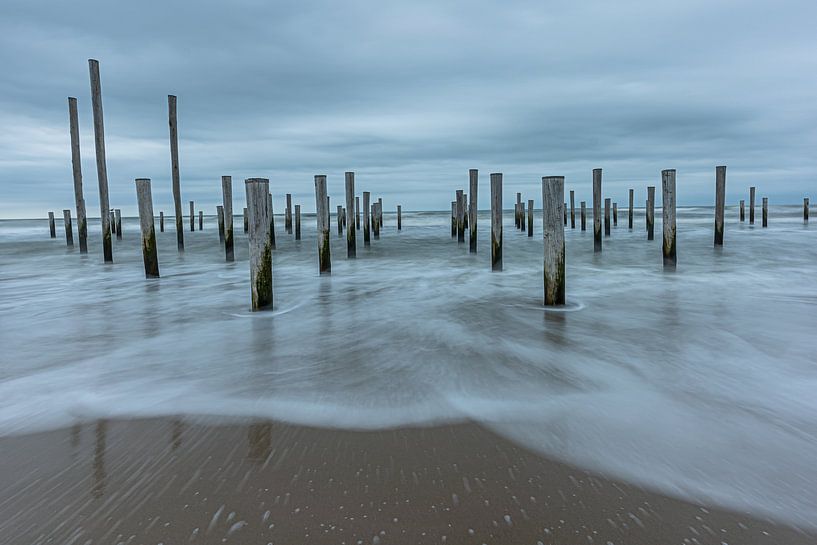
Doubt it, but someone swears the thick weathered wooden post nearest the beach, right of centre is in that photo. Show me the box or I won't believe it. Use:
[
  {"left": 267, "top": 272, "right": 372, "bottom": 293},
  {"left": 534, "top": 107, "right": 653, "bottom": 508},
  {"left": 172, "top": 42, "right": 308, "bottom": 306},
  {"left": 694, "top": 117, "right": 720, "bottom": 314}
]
[{"left": 544, "top": 176, "right": 564, "bottom": 306}]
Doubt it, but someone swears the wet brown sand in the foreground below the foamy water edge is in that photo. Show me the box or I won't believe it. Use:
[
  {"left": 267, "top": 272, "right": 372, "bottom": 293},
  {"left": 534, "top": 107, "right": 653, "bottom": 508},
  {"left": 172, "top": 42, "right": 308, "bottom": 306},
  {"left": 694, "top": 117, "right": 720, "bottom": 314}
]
[{"left": 0, "top": 419, "right": 817, "bottom": 545}]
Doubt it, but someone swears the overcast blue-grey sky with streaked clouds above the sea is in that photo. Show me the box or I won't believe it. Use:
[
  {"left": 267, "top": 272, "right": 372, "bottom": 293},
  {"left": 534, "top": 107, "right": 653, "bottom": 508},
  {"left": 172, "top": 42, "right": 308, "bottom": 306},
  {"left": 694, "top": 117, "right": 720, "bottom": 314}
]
[{"left": 0, "top": 0, "right": 817, "bottom": 217}]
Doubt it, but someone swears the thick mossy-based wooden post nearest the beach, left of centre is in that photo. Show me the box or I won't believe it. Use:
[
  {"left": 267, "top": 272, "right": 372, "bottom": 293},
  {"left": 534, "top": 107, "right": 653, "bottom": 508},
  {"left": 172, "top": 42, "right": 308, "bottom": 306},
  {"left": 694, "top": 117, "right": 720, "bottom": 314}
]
[{"left": 244, "top": 178, "right": 272, "bottom": 310}]
